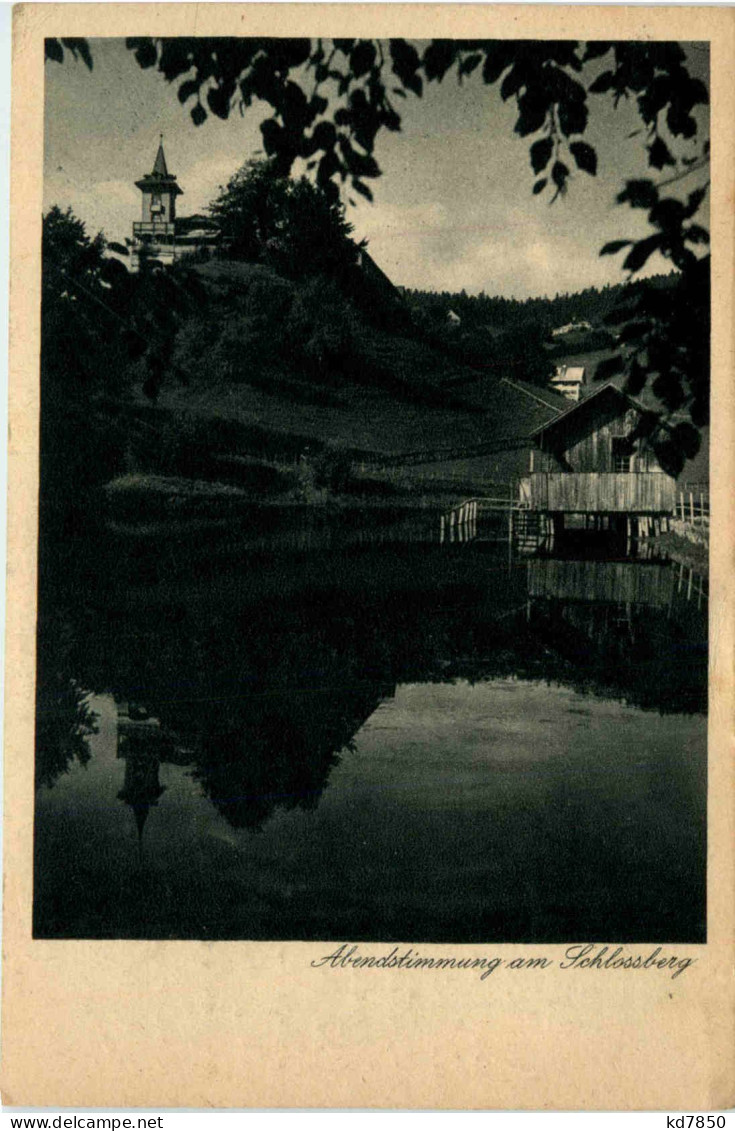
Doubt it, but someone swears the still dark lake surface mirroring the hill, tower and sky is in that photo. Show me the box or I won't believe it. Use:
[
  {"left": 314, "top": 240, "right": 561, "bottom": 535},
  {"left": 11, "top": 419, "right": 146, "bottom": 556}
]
[{"left": 34, "top": 529, "right": 707, "bottom": 942}]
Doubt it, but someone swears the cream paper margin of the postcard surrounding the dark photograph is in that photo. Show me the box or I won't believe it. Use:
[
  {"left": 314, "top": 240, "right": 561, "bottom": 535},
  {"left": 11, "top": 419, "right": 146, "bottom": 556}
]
[{"left": 2, "top": 3, "right": 735, "bottom": 1112}]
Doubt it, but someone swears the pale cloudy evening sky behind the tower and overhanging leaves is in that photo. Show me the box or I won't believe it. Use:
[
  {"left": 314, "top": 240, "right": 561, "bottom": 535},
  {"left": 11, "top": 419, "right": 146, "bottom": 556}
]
[{"left": 43, "top": 40, "right": 708, "bottom": 299}]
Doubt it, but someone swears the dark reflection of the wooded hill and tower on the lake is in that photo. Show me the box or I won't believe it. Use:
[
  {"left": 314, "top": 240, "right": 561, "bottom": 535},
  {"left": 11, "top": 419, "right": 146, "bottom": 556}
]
[{"left": 36, "top": 547, "right": 707, "bottom": 832}]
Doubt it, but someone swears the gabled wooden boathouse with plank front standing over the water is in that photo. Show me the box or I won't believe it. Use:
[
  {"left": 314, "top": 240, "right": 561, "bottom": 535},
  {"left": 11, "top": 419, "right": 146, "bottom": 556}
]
[{"left": 519, "top": 382, "right": 676, "bottom": 534}]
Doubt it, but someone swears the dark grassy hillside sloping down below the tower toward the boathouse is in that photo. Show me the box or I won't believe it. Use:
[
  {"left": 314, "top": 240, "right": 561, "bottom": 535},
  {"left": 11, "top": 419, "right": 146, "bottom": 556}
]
[{"left": 134, "top": 261, "right": 563, "bottom": 497}]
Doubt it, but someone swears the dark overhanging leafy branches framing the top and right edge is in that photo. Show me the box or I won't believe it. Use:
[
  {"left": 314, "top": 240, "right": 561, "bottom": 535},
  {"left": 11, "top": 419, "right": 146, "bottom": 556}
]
[{"left": 46, "top": 37, "right": 709, "bottom": 472}]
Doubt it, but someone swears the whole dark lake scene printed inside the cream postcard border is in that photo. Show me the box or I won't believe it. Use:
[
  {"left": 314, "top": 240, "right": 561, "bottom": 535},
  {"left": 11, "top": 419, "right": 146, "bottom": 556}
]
[{"left": 35, "top": 35, "right": 714, "bottom": 945}]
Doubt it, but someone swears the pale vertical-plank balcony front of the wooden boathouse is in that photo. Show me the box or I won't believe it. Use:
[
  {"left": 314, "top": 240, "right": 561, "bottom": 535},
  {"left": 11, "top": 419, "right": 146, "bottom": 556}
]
[{"left": 527, "top": 472, "right": 676, "bottom": 515}]
